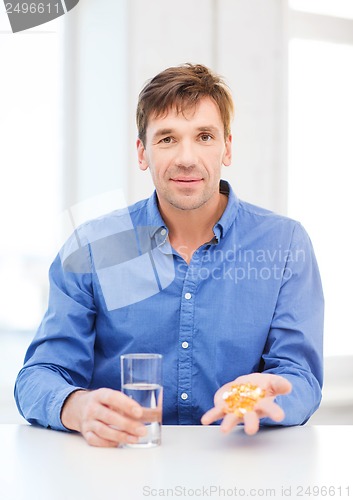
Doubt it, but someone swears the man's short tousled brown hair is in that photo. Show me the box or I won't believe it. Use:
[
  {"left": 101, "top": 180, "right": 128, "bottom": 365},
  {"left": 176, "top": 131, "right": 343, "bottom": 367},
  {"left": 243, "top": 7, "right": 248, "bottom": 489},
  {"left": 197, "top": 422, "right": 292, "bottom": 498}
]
[{"left": 136, "top": 63, "right": 234, "bottom": 144}]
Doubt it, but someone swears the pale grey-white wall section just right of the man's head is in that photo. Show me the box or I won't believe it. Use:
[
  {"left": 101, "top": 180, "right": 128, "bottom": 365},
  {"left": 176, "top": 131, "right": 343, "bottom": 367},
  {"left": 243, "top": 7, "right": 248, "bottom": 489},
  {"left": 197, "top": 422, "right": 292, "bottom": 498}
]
[{"left": 216, "top": 0, "right": 287, "bottom": 213}]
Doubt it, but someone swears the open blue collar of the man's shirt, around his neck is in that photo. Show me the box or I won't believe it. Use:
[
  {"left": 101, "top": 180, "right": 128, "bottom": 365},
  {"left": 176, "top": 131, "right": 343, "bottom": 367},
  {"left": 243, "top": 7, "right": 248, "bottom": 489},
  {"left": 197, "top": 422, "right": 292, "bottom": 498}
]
[{"left": 147, "top": 179, "right": 239, "bottom": 240}]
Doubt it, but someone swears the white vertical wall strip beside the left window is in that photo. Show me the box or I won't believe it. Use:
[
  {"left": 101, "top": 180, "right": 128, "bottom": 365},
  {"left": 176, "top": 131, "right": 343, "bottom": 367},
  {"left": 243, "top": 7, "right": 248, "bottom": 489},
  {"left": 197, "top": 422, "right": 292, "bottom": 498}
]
[{"left": 62, "top": 0, "right": 129, "bottom": 208}]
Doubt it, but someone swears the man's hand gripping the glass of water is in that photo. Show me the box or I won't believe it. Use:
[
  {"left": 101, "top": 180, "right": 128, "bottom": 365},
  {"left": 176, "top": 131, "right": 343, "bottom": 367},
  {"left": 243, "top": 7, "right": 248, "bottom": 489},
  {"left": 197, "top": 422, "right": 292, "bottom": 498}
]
[{"left": 61, "top": 389, "right": 146, "bottom": 448}]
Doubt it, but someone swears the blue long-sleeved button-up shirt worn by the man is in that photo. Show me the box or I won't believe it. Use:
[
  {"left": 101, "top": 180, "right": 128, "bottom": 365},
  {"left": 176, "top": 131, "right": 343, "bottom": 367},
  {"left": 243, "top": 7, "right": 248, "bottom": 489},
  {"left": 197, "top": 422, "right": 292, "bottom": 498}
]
[{"left": 15, "top": 181, "right": 323, "bottom": 429}]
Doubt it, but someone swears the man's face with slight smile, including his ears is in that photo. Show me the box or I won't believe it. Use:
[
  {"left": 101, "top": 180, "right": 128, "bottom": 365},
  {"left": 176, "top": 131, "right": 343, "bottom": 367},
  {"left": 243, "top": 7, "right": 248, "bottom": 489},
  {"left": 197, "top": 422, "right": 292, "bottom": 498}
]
[{"left": 137, "top": 97, "right": 231, "bottom": 210}]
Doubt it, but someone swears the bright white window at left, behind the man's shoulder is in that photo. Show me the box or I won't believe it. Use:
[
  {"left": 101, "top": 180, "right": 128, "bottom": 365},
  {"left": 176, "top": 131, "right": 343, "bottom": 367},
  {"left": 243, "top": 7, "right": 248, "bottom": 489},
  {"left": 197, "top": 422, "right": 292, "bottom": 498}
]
[{"left": 0, "top": 21, "right": 62, "bottom": 331}]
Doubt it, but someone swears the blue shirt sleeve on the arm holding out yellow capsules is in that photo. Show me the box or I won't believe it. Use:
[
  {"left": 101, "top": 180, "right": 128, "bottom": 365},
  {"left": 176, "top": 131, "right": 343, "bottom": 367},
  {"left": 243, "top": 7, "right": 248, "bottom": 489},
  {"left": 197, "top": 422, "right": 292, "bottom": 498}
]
[{"left": 262, "top": 223, "right": 324, "bottom": 425}]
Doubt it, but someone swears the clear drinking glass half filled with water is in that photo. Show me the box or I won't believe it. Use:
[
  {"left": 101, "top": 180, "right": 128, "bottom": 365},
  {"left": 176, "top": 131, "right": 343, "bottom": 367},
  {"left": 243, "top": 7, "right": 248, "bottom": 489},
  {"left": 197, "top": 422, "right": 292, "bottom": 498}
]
[{"left": 120, "top": 353, "right": 163, "bottom": 448}]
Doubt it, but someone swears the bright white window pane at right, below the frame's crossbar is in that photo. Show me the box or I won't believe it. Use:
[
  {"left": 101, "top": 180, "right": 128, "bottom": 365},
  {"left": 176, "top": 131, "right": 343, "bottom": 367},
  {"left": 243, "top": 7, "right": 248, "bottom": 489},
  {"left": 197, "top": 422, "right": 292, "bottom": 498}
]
[{"left": 288, "top": 39, "right": 353, "bottom": 355}]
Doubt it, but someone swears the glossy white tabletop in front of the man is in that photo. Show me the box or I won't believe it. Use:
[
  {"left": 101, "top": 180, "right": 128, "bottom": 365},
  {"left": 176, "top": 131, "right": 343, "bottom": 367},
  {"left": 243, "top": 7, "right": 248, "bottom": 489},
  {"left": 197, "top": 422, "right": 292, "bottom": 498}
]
[{"left": 0, "top": 425, "right": 353, "bottom": 500}]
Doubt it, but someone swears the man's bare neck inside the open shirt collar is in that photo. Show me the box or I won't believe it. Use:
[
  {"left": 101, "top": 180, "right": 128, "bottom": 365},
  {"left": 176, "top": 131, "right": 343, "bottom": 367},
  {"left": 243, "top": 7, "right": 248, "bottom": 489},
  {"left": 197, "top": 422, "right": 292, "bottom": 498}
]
[{"left": 159, "top": 193, "right": 228, "bottom": 263}]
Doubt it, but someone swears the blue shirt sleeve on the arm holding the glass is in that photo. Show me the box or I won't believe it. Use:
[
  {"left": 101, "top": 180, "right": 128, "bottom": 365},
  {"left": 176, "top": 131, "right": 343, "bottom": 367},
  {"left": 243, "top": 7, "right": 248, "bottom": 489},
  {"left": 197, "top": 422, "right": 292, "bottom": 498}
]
[{"left": 15, "top": 236, "right": 95, "bottom": 430}]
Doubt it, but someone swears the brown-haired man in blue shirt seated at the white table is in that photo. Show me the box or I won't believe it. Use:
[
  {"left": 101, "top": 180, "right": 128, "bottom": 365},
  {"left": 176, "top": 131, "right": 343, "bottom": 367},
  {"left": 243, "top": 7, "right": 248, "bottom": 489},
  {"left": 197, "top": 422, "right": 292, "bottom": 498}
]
[{"left": 15, "top": 60, "right": 323, "bottom": 446}]
